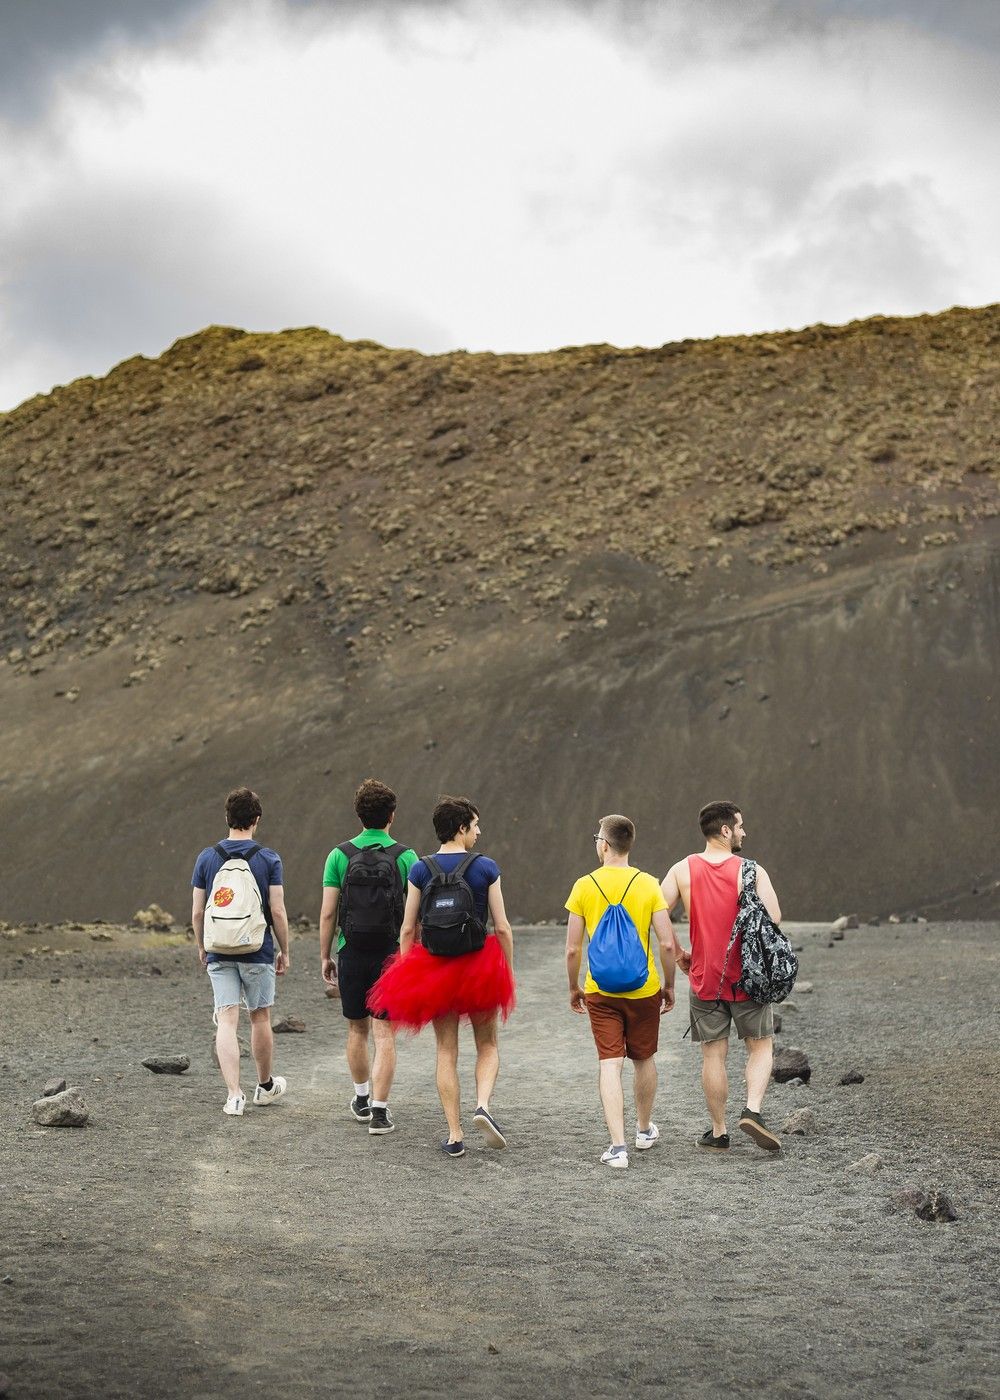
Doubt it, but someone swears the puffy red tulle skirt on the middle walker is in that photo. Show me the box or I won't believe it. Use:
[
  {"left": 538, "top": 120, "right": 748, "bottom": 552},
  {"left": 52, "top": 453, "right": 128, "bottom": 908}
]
[{"left": 368, "top": 934, "right": 517, "bottom": 1030}]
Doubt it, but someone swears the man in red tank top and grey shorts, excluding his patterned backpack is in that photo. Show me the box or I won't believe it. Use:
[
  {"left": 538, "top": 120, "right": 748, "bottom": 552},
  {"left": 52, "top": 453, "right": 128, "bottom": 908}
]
[{"left": 661, "top": 802, "right": 782, "bottom": 1152}]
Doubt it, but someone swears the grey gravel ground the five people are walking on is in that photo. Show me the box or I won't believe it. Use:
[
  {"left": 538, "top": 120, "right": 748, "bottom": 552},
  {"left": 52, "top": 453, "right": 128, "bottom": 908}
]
[{"left": 0, "top": 924, "right": 1000, "bottom": 1400}]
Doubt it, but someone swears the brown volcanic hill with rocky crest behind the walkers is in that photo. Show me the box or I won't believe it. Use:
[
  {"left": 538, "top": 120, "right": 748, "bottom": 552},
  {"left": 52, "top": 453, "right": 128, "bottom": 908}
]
[{"left": 0, "top": 307, "right": 1000, "bottom": 920}]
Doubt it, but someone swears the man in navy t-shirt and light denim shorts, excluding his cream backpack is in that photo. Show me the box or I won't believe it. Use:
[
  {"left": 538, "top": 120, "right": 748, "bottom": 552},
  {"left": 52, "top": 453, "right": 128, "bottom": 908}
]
[{"left": 190, "top": 788, "right": 289, "bottom": 1117}]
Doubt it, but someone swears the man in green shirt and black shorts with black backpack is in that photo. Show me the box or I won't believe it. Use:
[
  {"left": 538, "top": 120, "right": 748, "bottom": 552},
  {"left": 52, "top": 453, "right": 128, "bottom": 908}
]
[{"left": 319, "top": 778, "right": 417, "bottom": 1134}]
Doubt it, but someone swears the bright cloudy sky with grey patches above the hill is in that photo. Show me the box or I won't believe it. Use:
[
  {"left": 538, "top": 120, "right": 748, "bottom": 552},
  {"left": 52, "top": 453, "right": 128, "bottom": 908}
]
[{"left": 0, "top": 0, "right": 1000, "bottom": 409}]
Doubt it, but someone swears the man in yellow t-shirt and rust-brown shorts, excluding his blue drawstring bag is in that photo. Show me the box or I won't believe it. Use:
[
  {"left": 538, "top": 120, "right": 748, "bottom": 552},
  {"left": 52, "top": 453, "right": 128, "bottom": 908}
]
[{"left": 566, "top": 816, "right": 678, "bottom": 1168}]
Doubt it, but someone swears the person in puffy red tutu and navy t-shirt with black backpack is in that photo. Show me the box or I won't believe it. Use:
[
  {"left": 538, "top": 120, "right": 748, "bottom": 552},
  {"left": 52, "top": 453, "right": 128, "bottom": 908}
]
[{"left": 368, "top": 797, "right": 515, "bottom": 1156}]
